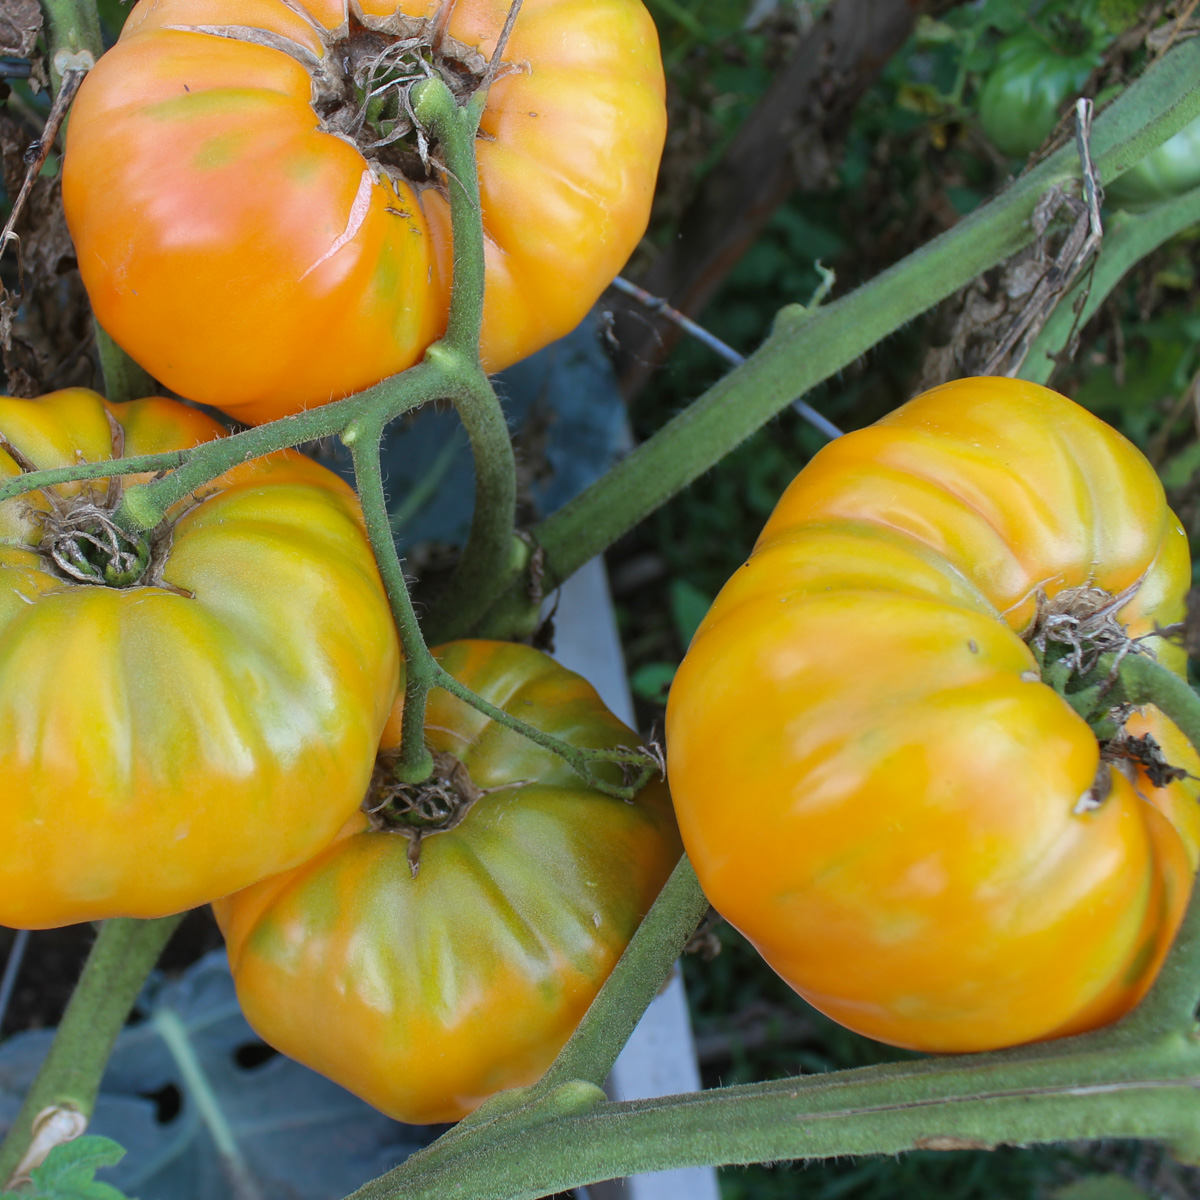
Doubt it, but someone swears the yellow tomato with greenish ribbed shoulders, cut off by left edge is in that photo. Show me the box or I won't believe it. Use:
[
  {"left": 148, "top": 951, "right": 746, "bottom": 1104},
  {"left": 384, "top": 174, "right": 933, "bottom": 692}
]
[{"left": 0, "top": 389, "right": 398, "bottom": 929}]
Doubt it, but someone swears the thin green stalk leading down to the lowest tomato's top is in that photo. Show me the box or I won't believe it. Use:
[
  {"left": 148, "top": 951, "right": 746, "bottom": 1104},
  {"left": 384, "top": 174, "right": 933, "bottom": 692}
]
[{"left": 350, "top": 421, "right": 440, "bottom": 784}]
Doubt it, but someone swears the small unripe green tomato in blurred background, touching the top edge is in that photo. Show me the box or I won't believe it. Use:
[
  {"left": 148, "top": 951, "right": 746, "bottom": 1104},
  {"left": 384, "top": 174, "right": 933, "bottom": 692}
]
[{"left": 979, "top": 0, "right": 1112, "bottom": 158}]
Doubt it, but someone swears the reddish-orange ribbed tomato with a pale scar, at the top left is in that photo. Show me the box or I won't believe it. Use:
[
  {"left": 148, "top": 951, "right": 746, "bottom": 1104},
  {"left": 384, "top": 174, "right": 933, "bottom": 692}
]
[{"left": 62, "top": 0, "right": 666, "bottom": 422}]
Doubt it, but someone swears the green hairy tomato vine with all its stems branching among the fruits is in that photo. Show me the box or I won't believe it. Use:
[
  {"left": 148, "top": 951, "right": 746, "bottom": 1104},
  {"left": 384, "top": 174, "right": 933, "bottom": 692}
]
[{"left": 0, "top": 0, "right": 1200, "bottom": 1200}]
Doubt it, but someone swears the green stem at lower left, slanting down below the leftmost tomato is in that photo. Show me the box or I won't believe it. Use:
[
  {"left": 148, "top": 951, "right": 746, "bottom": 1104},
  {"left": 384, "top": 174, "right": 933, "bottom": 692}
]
[{"left": 0, "top": 917, "right": 181, "bottom": 1186}]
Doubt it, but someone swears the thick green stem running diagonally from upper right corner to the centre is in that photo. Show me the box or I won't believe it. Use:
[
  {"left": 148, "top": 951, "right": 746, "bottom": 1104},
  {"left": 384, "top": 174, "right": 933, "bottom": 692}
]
[{"left": 480, "top": 38, "right": 1200, "bottom": 636}]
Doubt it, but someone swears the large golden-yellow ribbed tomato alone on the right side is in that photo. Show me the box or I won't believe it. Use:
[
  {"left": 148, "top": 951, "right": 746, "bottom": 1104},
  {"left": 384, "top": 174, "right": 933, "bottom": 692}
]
[{"left": 667, "top": 378, "right": 1200, "bottom": 1051}]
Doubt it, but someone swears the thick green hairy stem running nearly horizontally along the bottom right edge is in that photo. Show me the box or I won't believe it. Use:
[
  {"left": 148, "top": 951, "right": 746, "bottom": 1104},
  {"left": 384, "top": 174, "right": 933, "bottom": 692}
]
[{"left": 352, "top": 1027, "right": 1200, "bottom": 1200}]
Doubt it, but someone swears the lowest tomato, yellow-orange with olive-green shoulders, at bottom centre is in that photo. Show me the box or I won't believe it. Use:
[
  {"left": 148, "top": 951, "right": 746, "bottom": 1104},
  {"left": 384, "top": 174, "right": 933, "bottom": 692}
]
[{"left": 214, "top": 641, "right": 680, "bottom": 1122}]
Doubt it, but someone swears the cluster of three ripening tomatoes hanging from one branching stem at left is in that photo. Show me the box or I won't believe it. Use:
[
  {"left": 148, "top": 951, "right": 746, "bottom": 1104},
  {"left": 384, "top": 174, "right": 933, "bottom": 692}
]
[{"left": 0, "top": 0, "right": 680, "bottom": 1121}]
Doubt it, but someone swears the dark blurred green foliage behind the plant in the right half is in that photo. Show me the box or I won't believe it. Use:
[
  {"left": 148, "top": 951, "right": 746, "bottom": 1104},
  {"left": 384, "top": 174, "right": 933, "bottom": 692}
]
[{"left": 608, "top": 0, "right": 1200, "bottom": 1200}]
